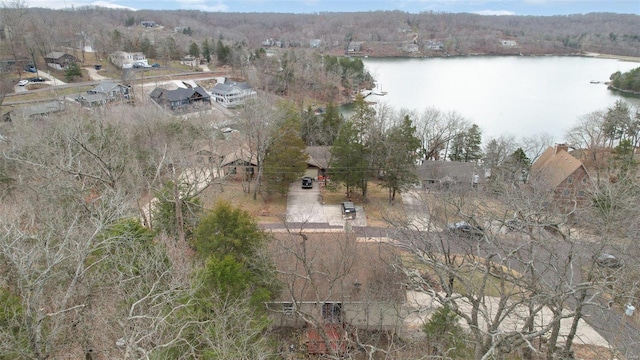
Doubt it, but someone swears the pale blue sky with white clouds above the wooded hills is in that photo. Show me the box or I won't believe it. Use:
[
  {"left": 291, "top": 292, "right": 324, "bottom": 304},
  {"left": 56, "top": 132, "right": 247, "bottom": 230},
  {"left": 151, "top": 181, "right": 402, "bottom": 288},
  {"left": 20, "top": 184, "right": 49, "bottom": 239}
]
[{"left": 26, "top": 0, "right": 640, "bottom": 15}]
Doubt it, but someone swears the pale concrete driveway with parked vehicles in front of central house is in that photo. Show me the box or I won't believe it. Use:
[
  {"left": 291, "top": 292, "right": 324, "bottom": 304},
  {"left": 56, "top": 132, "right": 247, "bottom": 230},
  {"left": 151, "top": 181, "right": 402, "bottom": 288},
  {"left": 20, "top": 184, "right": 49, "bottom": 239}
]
[{"left": 286, "top": 180, "right": 367, "bottom": 226}]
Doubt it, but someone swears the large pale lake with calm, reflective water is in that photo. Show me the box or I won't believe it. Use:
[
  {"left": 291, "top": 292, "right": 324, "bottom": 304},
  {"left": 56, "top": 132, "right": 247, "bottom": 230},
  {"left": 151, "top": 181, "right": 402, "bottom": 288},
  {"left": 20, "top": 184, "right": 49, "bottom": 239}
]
[{"left": 362, "top": 56, "right": 640, "bottom": 142}]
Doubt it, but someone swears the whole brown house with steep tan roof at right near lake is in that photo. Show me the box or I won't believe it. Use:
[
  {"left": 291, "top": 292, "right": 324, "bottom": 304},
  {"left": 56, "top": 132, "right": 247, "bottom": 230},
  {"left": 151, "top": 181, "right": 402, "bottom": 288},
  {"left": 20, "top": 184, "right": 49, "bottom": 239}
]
[{"left": 529, "top": 144, "right": 591, "bottom": 203}]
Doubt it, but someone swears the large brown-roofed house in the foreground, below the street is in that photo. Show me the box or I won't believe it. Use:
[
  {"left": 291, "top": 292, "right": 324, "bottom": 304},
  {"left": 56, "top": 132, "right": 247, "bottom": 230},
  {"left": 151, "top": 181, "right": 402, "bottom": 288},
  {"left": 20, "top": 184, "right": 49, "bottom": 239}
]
[{"left": 267, "top": 233, "right": 406, "bottom": 353}]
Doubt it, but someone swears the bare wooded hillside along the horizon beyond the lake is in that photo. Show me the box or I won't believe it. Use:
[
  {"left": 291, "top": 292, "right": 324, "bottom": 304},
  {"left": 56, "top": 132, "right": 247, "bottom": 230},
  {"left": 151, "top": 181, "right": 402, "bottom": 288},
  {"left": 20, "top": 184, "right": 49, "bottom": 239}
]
[{"left": 20, "top": 7, "right": 640, "bottom": 56}]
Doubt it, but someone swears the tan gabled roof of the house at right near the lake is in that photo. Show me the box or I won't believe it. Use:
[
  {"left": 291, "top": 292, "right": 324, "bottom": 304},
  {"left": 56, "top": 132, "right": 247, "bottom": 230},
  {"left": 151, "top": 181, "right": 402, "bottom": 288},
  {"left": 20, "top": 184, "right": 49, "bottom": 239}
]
[{"left": 530, "top": 146, "right": 586, "bottom": 188}]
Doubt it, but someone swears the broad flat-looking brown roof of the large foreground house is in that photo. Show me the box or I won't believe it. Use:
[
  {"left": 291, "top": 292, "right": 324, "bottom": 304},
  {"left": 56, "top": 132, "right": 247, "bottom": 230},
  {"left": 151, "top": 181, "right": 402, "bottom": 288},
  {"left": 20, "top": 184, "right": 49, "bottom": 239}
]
[{"left": 269, "top": 233, "right": 405, "bottom": 302}]
